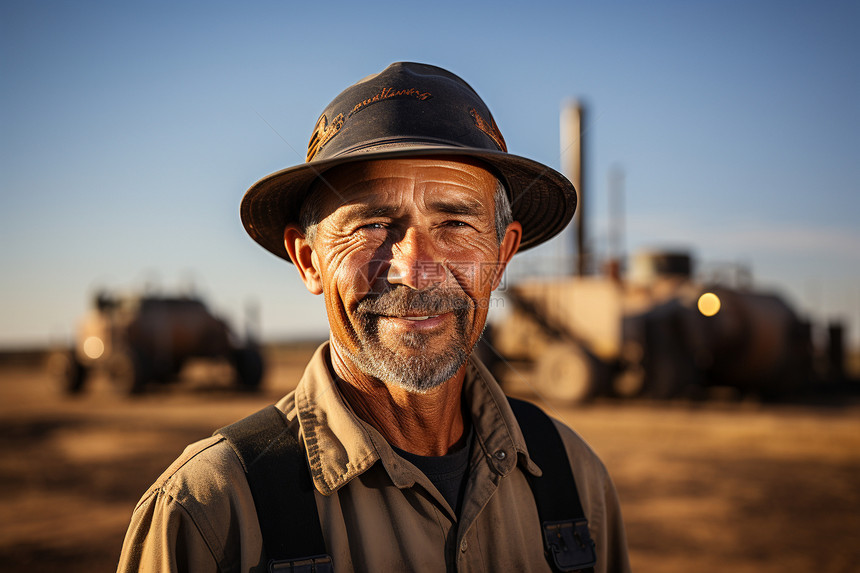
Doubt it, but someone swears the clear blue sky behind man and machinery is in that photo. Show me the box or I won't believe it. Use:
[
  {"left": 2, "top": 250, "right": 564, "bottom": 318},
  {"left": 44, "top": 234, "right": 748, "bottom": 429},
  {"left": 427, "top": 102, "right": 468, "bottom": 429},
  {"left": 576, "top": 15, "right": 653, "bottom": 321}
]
[{"left": 0, "top": 1, "right": 860, "bottom": 346}]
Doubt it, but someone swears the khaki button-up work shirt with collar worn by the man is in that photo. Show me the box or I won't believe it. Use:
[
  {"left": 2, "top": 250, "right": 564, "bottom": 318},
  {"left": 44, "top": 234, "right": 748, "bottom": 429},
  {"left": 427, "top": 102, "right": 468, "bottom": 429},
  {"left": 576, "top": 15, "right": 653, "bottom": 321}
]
[{"left": 118, "top": 343, "right": 629, "bottom": 573}]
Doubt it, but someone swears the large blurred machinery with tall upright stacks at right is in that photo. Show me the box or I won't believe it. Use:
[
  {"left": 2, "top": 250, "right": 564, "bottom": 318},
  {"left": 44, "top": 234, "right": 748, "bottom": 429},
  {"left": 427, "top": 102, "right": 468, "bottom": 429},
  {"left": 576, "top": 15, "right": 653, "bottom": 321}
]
[{"left": 478, "top": 102, "right": 842, "bottom": 402}]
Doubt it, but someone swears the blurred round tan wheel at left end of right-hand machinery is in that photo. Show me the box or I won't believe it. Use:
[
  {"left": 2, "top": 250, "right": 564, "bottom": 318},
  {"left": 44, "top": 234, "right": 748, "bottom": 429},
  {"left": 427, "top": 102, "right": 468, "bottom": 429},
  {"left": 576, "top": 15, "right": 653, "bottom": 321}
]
[{"left": 534, "top": 343, "right": 605, "bottom": 404}]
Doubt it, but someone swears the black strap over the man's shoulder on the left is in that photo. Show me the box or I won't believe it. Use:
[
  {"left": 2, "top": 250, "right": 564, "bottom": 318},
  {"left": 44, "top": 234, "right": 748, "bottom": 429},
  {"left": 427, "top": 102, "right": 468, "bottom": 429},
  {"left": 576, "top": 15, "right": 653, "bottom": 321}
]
[{"left": 215, "top": 406, "right": 332, "bottom": 573}]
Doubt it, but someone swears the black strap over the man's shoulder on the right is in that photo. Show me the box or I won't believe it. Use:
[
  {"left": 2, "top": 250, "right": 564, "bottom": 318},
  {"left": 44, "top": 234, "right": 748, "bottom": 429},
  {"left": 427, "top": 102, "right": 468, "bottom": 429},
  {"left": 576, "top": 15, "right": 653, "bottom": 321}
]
[{"left": 508, "top": 398, "right": 597, "bottom": 573}]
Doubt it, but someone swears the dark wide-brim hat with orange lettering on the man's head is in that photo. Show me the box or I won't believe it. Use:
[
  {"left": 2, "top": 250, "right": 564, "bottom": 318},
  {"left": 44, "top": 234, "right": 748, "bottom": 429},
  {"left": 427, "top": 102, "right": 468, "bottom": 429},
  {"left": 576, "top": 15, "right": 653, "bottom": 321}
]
[{"left": 240, "top": 62, "right": 576, "bottom": 261}]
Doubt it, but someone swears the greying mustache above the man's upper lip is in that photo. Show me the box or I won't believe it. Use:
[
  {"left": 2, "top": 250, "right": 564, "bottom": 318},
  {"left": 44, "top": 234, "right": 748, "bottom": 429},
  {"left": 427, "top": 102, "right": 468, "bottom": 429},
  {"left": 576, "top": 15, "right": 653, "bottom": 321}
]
[{"left": 356, "top": 285, "right": 472, "bottom": 316}]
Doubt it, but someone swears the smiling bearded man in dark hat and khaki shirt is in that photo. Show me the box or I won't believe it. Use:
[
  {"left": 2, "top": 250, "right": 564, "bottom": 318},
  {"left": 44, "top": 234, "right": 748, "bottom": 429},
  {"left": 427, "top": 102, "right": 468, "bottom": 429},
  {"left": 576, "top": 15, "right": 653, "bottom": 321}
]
[{"left": 120, "top": 63, "right": 629, "bottom": 572}]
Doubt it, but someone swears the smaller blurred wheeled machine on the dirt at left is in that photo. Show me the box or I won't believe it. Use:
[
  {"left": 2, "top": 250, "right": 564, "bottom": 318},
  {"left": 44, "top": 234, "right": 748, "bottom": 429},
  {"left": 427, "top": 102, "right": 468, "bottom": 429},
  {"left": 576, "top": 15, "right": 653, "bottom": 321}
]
[{"left": 49, "top": 292, "right": 264, "bottom": 394}]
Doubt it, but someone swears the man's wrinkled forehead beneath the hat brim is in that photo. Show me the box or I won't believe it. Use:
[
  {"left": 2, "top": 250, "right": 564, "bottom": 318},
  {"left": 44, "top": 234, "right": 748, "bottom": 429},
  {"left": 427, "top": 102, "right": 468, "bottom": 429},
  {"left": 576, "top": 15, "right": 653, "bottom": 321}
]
[{"left": 311, "top": 158, "right": 498, "bottom": 217}]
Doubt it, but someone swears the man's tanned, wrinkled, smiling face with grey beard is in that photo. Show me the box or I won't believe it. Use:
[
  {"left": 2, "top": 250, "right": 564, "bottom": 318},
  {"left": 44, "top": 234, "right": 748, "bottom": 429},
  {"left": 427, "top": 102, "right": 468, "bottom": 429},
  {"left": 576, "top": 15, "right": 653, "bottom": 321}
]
[{"left": 286, "top": 159, "right": 520, "bottom": 392}]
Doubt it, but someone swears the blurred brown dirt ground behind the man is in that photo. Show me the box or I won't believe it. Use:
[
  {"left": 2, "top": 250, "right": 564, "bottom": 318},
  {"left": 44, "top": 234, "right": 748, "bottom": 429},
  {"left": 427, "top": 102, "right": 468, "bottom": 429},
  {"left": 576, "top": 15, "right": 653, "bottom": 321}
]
[{"left": 0, "top": 347, "right": 860, "bottom": 573}]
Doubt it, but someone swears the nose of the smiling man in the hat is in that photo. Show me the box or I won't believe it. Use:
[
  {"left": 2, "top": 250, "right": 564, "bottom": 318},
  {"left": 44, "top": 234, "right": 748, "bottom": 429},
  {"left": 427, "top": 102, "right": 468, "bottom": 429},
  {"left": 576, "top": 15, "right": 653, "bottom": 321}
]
[{"left": 387, "top": 228, "right": 445, "bottom": 290}]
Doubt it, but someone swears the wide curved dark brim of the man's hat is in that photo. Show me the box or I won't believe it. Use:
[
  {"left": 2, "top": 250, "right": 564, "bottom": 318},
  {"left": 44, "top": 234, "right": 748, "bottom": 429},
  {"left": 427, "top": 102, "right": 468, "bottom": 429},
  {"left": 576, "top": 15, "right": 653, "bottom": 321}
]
[{"left": 240, "top": 145, "right": 576, "bottom": 261}]
